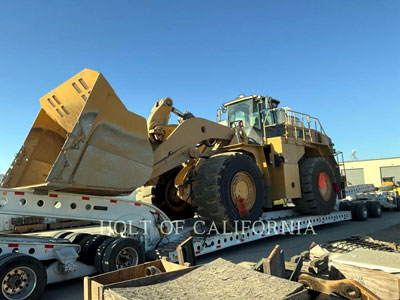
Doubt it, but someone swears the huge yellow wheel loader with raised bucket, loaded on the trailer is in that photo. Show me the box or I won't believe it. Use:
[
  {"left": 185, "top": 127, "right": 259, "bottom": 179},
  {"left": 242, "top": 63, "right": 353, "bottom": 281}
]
[{"left": 1, "top": 69, "right": 340, "bottom": 228}]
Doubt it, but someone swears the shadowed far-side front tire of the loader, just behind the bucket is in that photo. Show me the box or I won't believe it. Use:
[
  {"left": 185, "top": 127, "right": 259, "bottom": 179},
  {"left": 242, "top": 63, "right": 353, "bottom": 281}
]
[{"left": 141, "top": 169, "right": 194, "bottom": 220}]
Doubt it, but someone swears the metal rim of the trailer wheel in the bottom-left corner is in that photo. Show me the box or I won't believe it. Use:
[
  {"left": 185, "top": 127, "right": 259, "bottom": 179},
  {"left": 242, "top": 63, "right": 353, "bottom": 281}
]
[{"left": 1, "top": 267, "right": 37, "bottom": 300}]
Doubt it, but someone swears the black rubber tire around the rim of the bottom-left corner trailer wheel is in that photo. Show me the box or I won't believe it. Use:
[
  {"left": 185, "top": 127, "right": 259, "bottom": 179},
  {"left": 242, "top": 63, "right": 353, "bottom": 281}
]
[{"left": 0, "top": 253, "right": 47, "bottom": 300}]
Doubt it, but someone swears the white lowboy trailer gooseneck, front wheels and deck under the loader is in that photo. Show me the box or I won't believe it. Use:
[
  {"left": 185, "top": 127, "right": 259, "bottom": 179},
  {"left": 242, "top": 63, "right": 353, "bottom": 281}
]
[{"left": 0, "top": 189, "right": 352, "bottom": 300}]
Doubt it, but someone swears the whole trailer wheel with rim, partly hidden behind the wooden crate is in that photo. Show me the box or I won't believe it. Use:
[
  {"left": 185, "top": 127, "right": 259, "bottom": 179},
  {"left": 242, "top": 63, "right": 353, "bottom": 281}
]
[{"left": 102, "top": 238, "right": 145, "bottom": 272}]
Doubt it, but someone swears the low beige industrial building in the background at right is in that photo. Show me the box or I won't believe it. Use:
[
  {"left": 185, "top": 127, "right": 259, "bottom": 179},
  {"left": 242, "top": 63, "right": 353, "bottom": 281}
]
[{"left": 340, "top": 157, "right": 400, "bottom": 186}]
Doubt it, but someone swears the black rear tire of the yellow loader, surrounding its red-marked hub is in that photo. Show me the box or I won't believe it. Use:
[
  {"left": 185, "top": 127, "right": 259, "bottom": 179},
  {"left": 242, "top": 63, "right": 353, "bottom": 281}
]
[{"left": 293, "top": 157, "right": 336, "bottom": 215}]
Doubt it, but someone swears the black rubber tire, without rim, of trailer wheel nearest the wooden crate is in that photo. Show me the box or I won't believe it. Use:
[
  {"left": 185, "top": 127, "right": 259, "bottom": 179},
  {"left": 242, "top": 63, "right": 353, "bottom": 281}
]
[{"left": 102, "top": 238, "right": 145, "bottom": 272}]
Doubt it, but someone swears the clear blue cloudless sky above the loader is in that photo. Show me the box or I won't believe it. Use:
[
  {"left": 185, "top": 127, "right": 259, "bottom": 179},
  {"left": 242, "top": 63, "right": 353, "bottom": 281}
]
[{"left": 0, "top": 0, "right": 400, "bottom": 173}]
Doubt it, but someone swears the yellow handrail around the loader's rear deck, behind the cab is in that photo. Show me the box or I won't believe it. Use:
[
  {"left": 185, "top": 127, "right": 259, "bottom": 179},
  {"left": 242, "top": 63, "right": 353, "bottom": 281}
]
[{"left": 263, "top": 107, "right": 327, "bottom": 142}]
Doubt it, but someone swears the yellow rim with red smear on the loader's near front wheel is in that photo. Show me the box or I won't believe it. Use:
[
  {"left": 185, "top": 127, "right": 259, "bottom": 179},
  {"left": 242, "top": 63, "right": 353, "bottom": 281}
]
[{"left": 231, "top": 171, "right": 256, "bottom": 217}]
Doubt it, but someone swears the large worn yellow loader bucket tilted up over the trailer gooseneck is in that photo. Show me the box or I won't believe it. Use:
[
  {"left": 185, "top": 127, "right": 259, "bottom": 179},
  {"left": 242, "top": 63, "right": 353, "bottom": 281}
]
[{"left": 2, "top": 69, "right": 153, "bottom": 195}]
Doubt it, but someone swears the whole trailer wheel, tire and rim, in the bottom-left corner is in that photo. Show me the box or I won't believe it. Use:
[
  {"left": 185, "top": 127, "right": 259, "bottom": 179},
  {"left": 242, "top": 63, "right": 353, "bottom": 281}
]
[{"left": 0, "top": 253, "right": 47, "bottom": 300}]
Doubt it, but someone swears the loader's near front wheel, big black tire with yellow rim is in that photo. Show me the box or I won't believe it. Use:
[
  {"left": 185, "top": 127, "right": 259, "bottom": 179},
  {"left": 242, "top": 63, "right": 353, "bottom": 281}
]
[{"left": 193, "top": 152, "right": 266, "bottom": 230}]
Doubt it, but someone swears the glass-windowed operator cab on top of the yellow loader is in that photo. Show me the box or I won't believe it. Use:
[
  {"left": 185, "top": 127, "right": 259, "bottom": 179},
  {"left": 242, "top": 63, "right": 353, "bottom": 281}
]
[{"left": 217, "top": 95, "right": 279, "bottom": 145}]
